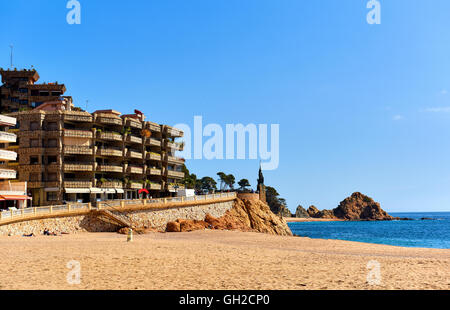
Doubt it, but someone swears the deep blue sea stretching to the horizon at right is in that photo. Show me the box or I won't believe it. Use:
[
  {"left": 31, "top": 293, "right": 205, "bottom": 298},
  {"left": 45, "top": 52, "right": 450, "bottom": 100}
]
[{"left": 288, "top": 212, "right": 450, "bottom": 249}]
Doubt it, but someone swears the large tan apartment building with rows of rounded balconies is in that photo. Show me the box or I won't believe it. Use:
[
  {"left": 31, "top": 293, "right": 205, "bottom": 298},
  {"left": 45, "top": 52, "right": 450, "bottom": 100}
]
[{"left": 12, "top": 96, "right": 184, "bottom": 206}]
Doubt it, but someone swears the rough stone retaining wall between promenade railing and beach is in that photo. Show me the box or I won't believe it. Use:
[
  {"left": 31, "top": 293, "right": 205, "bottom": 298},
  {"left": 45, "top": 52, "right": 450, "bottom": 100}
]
[{"left": 0, "top": 201, "right": 234, "bottom": 236}]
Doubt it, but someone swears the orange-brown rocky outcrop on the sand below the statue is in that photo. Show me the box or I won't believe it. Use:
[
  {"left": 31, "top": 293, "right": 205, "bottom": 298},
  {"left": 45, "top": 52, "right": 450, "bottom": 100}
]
[{"left": 166, "top": 199, "right": 292, "bottom": 236}]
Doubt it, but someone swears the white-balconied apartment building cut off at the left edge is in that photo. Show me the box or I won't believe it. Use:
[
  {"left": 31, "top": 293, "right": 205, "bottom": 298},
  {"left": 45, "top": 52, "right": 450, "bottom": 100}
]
[{"left": 0, "top": 115, "right": 28, "bottom": 210}]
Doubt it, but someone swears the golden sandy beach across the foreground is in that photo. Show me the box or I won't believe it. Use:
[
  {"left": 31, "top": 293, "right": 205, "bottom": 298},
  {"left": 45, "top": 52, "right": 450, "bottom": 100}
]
[{"left": 0, "top": 231, "right": 450, "bottom": 290}]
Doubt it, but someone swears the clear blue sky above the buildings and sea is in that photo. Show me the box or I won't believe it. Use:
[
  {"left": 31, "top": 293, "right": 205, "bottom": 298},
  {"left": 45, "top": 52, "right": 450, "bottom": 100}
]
[{"left": 0, "top": 0, "right": 450, "bottom": 211}]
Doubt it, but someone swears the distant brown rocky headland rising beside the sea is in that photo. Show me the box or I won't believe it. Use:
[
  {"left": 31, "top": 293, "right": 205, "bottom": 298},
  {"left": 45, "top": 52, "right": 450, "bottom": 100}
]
[{"left": 308, "top": 193, "right": 398, "bottom": 221}]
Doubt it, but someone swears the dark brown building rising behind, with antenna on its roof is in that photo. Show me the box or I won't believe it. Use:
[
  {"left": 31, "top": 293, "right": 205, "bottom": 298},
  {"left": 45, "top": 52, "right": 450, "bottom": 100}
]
[{"left": 0, "top": 68, "right": 66, "bottom": 112}]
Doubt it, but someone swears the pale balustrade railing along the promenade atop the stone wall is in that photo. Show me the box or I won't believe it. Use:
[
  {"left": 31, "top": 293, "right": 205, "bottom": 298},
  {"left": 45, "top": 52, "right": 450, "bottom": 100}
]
[{"left": 0, "top": 192, "right": 236, "bottom": 225}]
